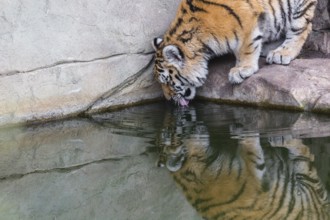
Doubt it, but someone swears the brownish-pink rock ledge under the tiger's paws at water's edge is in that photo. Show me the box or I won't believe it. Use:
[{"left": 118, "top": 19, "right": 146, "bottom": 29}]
[{"left": 197, "top": 57, "right": 330, "bottom": 111}]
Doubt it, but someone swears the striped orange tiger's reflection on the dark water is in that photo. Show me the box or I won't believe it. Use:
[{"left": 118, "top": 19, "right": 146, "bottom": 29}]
[{"left": 157, "top": 107, "right": 330, "bottom": 220}]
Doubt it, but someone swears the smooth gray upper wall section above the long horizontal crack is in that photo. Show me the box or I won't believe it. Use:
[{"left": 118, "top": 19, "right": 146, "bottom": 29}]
[{"left": 0, "top": 0, "right": 179, "bottom": 73}]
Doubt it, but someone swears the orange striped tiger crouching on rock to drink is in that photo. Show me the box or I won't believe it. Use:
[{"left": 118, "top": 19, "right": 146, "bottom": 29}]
[{"left": 152, "top": 0, "right": 317, "bottom": 106}]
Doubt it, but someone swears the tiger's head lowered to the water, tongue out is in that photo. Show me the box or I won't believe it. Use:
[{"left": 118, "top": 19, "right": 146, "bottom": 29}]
[{"left": 153, "top": 38, "right": 207, "bottom": 106}]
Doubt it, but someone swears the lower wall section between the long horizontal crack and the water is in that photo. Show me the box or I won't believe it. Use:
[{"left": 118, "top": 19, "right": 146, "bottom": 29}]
[{"left": 0, "top": 54, "right": 160, "bottom": 124}]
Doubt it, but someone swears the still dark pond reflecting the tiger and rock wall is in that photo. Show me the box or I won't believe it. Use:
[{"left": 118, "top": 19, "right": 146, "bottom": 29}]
[{"left": 0, "top": 102, "right": 330, "bottom": 220}]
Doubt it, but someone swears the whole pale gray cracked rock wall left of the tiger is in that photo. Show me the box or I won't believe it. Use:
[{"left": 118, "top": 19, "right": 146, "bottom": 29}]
[{"left": 0, "top": 0, "right": 180, "bottom": 125}]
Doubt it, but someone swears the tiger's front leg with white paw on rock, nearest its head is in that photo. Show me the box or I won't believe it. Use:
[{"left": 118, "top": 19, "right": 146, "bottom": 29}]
[{"left": 229, "top": 32, "right": 262, "bottom": 84}]
